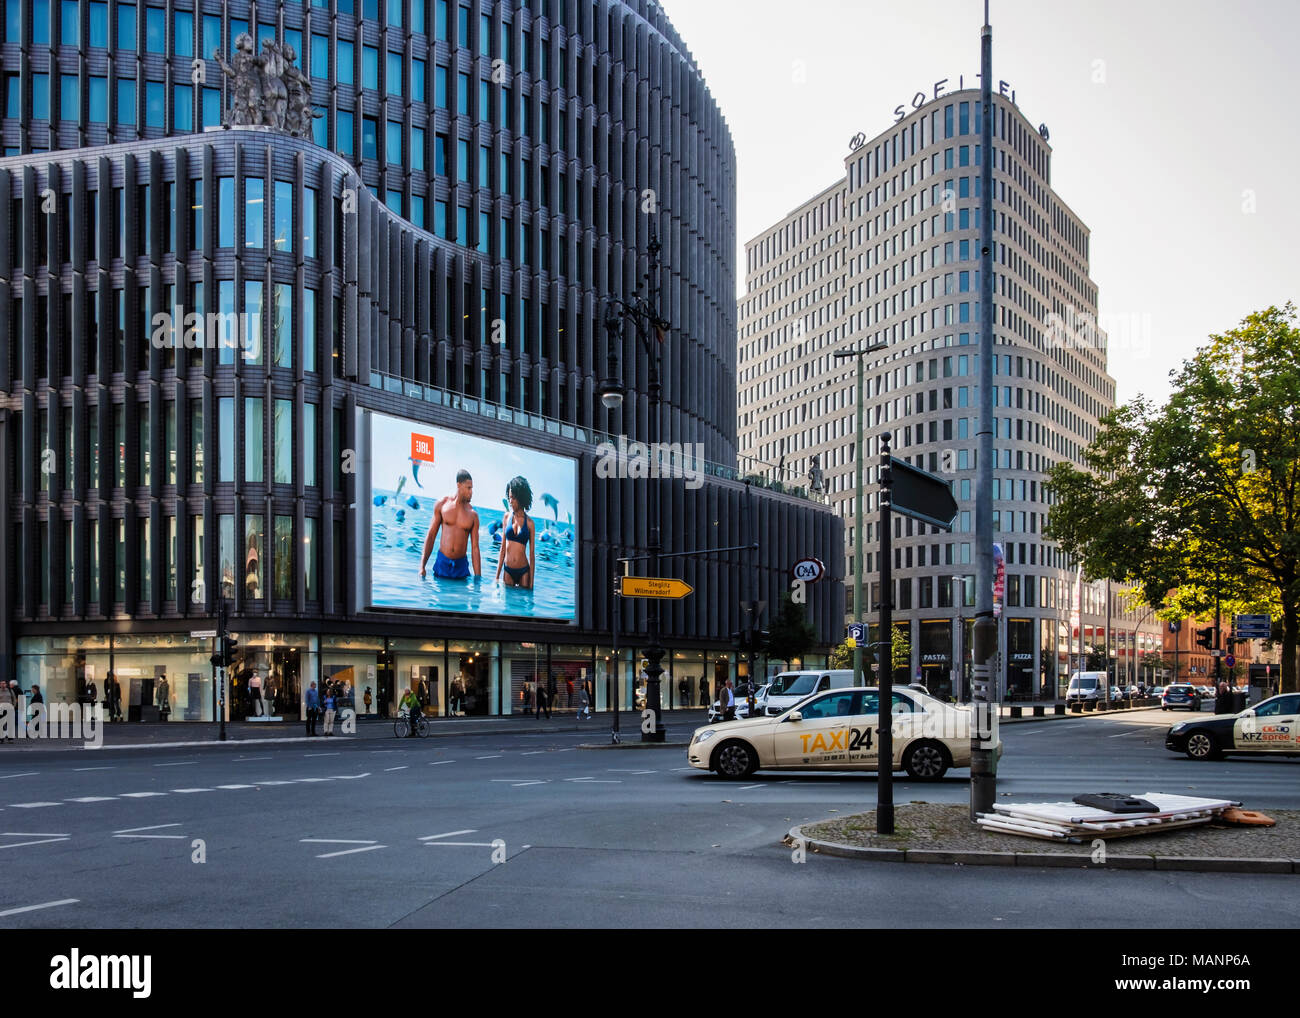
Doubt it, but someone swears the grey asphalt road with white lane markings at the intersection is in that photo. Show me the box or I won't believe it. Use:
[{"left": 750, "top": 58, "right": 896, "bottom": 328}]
[{"left": 0, "top": 710, "right": 1300, "bottom": 928}]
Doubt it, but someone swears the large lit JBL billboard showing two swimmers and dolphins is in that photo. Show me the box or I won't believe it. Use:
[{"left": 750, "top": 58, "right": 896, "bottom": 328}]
[{"left": 367, "top": 412, "right": 580, "bottom": 620}]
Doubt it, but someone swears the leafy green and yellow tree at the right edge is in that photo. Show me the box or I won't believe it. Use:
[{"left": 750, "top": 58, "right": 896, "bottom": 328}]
[{"left": 1045, "top": 304, "right": 1300, "bottom": 692}]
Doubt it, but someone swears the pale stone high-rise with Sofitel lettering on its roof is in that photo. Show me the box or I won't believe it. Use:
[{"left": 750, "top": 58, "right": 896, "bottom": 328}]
[{"left": 738, "top": 86, "right": 1161, "bottom": 698}]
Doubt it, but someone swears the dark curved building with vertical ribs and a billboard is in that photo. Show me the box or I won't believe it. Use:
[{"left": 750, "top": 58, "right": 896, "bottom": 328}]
[{"left": 0, "top": 0, "right": 844, "bottom": 720}]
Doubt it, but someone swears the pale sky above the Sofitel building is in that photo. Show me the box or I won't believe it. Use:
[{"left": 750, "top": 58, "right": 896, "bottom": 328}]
[{"left": 660, "top": 0, "right": 1300, "bottom": 402}]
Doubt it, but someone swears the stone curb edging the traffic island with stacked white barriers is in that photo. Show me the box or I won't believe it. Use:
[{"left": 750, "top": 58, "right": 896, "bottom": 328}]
[{"left": 781, "top": 826, "right": 1300, "bottom": 874}]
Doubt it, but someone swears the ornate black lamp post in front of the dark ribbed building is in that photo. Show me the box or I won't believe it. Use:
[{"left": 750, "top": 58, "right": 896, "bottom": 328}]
[{"left": 601, "top": 235, "right": 670, "bottom": 742}]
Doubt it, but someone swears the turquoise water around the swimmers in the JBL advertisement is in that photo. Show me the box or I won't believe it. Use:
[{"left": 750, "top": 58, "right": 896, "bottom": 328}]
[{"left": 371, "top": 486, "right": 577, "bottom": 619}]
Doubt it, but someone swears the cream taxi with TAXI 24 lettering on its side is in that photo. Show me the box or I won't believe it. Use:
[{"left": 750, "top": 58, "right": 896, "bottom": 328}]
[{"left": 686, "top": 686, "right": 1002, "bottom": 781}]
